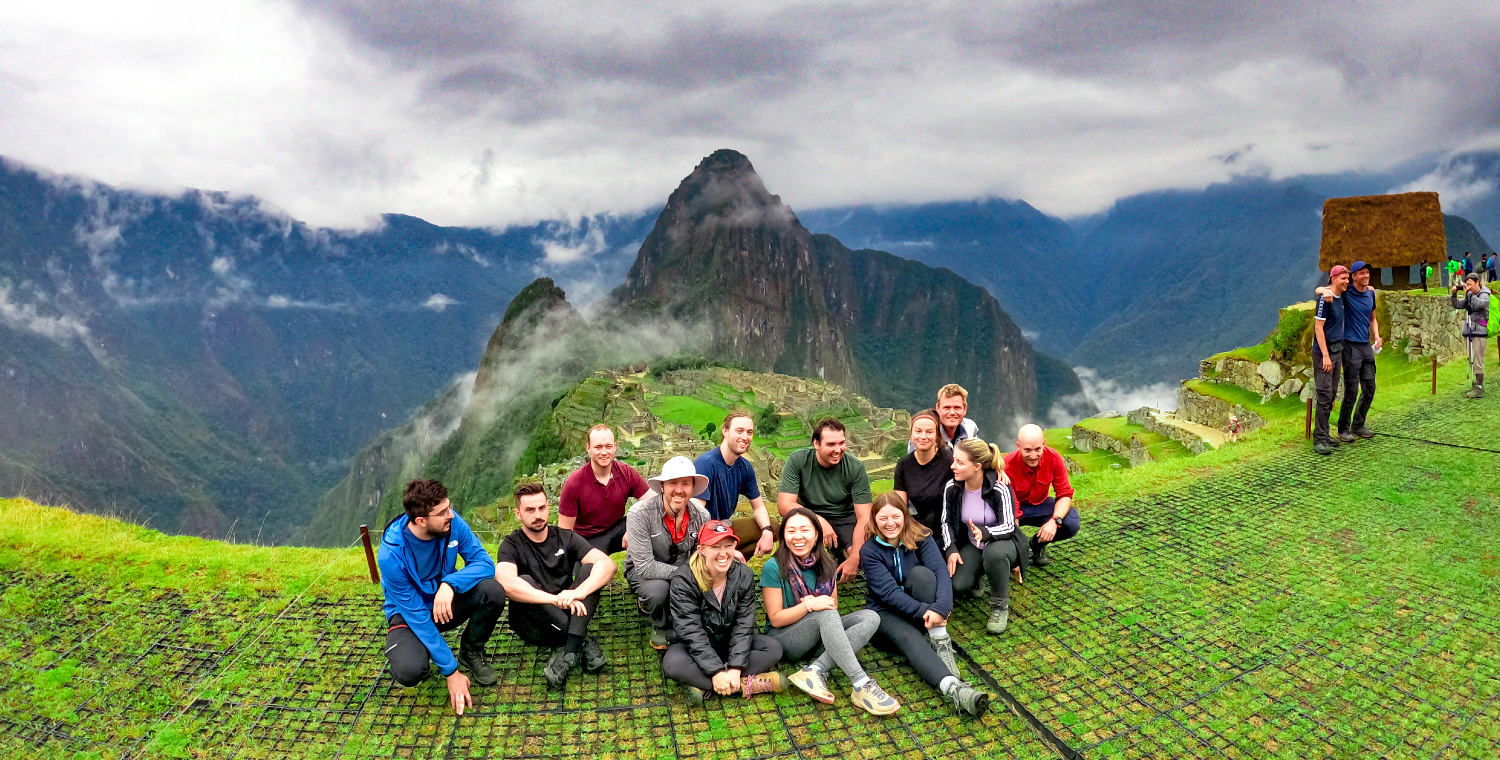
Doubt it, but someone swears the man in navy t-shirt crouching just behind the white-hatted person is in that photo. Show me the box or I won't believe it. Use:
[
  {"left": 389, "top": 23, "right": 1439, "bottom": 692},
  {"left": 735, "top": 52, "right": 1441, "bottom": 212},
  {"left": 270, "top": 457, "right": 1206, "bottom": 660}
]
[{"left": 693, "top": 409, "right": 776, "bottom": 556}]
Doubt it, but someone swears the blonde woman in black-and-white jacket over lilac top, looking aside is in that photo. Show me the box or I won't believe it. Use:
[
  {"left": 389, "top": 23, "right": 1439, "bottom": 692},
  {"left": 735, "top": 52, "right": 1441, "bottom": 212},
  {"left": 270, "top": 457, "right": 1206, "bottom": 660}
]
[{"left": 939, "top": 438, "right": 1028, "bottom": 634}]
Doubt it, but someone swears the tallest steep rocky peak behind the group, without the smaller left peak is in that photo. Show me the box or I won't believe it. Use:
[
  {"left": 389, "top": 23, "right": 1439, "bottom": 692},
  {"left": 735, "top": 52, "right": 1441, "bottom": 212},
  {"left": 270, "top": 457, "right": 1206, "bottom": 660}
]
[{"left": 614, "top": 150, "right": 1080, "bottom": 430}]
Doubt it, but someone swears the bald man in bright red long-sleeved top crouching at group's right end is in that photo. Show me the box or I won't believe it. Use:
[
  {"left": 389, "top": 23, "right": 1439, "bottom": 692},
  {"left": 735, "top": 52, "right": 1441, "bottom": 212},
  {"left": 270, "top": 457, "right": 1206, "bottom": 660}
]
[{"left": 1005, "top": 424, "right": 1079, "bottom": 567}]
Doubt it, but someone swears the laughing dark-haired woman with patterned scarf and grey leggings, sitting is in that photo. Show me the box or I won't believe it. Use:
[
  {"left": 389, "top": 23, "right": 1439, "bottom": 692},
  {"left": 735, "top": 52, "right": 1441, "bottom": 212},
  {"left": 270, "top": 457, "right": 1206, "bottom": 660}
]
[{"left": 761, "top": 507, "right": 902, "bottom": 715}]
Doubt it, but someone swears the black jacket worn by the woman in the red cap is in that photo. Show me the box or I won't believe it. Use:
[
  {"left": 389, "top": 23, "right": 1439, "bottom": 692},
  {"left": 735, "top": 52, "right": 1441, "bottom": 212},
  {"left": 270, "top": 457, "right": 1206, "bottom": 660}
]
[{"left": 668, "top": 562, "right": 758, "bottom": 675}]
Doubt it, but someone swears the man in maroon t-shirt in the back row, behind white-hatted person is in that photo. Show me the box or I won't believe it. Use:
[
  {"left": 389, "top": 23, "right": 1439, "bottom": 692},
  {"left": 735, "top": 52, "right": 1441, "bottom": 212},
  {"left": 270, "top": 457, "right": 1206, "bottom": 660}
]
[{"left": 558, "top": 424, "right": 650, "bottom": 555}]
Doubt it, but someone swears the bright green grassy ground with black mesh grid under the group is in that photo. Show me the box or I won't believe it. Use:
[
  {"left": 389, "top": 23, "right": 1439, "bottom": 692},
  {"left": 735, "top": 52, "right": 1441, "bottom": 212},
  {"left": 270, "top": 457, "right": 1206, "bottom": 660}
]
[{"left": 0, "top": 353, "right": 1500, "bottom": 760}]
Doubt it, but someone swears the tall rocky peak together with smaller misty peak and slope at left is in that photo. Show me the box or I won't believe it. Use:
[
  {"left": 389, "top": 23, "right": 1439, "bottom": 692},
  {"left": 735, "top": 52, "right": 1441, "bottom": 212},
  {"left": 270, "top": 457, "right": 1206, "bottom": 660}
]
[{"left": 309, "top": 150, "right": 1080, "bottom": 537}]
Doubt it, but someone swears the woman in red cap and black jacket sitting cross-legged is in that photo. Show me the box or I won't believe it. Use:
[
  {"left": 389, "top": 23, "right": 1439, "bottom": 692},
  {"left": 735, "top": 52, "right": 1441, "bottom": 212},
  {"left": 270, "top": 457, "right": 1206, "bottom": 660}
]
[{"left": 662, "top": 520, "right": 782, "bottom": 705}]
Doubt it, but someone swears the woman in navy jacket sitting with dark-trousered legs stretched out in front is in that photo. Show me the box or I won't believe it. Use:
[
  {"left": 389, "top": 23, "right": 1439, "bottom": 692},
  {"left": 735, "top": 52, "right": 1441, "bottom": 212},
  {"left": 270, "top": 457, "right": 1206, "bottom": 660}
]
[{"left": 860, "top": 492, "right": 990, "bottom": 718}]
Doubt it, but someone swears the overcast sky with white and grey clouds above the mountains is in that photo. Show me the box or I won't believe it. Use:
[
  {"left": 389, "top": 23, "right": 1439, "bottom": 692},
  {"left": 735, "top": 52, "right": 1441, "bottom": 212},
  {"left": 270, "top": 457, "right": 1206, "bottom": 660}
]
[{"left": 0, "top": 0, "right": 1500, "bottom": 226}]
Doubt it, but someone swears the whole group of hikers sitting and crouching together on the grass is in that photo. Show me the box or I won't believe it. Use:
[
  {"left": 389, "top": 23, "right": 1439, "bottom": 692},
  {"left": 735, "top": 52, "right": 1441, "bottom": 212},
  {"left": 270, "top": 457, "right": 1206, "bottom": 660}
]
[{"left": 380, "top": 385, "right": 1079, "bottom": 717}]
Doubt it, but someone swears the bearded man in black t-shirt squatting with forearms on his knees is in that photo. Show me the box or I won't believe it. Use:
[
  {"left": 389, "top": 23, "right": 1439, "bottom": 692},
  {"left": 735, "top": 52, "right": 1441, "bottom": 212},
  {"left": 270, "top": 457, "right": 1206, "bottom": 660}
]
[{"left": 495, "top": 483, "right": 615, "bottom": 688}]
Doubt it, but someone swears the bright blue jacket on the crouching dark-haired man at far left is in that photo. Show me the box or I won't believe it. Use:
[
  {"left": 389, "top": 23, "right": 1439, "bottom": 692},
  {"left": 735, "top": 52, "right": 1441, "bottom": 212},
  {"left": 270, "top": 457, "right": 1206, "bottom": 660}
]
[{"left": 378, "top": 514, "right": 495, "bottom": 676}]
